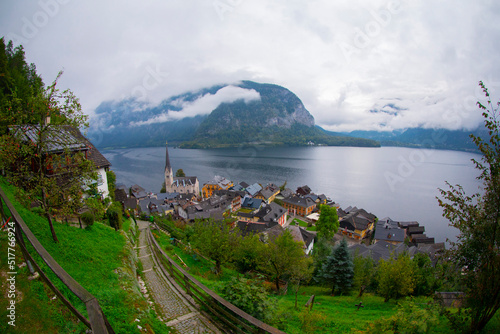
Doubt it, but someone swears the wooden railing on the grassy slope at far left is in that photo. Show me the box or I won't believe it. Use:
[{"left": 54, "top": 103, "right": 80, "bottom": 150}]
[{"left": 0, "top": 188, "right": 114, "bottom": 334}]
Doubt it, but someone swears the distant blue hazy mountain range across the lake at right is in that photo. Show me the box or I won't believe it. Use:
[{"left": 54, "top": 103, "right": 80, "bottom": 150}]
[{"left": 343, "top": 128, "right": 489, "bottom": 152}]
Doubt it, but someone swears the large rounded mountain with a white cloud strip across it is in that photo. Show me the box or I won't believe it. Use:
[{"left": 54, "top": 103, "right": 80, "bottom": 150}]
[{"left": 88, "top": 81, "right": 379, "bottom": 148}]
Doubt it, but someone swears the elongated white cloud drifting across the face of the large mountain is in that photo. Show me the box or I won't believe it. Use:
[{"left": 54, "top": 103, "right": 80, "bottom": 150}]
[{"left": 130, "top": 85, "right": 260, "bottom": 126}]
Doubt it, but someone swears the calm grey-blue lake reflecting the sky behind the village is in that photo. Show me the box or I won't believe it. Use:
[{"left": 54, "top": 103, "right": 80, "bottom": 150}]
[{"left": 102, "top": 147, "right": 480, "bottom": 242}]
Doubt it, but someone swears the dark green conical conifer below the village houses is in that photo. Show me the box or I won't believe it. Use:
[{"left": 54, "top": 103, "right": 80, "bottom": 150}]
[{"left": 317, "top": 239, "right": 354, "bottom": 296}]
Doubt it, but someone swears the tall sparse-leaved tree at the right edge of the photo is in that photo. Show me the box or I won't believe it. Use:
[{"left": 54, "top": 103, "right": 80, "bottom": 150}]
[{"left": 438, "top": 81, "right": 500, "bottom": 332}]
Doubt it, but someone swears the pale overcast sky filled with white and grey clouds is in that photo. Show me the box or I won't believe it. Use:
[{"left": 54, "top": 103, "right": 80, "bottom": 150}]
[{"left": 0, "top": 0, "right": 500, "bottom": 131}]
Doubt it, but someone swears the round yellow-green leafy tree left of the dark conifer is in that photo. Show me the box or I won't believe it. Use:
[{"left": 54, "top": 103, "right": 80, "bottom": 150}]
[{"left": 261, "top": 230, "right": 308, "bottom": 291}]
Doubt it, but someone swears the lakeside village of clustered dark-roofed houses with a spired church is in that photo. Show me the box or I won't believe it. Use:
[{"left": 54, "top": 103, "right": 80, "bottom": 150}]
[{"left": 115, "top": 145, "right": 445, "bottom": 261}]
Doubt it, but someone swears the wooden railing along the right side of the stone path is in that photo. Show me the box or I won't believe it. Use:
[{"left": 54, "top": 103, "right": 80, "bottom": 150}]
[{"left": 148, "top": 224, "right": 285, "bottom": 334}]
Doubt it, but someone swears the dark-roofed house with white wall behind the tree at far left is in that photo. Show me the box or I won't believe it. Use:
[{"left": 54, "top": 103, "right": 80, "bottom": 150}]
[{"left": 9, "top": 124, "right": 111, "bottom": 197}]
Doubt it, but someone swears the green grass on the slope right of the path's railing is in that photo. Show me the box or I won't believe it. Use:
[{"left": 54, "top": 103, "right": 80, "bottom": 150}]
[{"left": 150, "top": 224, "right": 500, "bottom": 334}]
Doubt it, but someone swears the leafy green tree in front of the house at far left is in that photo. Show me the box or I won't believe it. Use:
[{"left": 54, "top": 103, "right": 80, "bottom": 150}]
[{"left": 0, "top": 58, "right": 97, "bottom": 242}]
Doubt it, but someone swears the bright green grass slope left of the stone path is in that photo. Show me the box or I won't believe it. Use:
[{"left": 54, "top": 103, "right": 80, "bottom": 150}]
[{"left": 0, "top": 179, "right": 168, "bottom": 333}]
